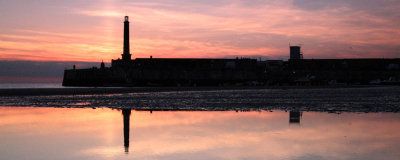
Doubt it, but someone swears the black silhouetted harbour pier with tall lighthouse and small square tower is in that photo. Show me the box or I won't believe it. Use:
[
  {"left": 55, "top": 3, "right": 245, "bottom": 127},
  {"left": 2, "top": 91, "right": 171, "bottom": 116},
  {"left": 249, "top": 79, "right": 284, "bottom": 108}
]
[{"left": 63, "top": 16, "right": 400, "bottom": 87}]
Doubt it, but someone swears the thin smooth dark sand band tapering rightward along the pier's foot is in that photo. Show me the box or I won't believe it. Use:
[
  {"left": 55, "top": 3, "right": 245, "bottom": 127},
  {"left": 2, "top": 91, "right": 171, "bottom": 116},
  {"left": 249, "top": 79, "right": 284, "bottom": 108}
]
[{"left": 0, "top": 85, "right": 390, "bottom": 97}]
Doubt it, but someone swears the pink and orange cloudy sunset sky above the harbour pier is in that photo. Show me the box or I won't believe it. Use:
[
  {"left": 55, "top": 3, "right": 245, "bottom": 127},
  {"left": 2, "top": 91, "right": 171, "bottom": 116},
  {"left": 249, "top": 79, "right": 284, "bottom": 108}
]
[{"left": 0, "top": 0, "right": 400, "bottom": 81}]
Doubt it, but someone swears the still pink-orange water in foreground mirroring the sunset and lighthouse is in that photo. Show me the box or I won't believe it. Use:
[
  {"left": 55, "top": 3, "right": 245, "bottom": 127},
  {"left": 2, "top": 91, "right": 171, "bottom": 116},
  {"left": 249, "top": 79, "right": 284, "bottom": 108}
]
[{"left": 0, "top": 107, "right": 400, "bottom": 160}]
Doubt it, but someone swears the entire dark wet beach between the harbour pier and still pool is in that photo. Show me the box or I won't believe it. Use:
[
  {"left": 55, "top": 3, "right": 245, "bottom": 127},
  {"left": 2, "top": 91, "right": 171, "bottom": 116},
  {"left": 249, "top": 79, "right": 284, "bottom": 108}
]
[{"left": 0, "top": 86, "right": 400, "bottom": 113}]
